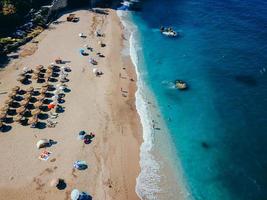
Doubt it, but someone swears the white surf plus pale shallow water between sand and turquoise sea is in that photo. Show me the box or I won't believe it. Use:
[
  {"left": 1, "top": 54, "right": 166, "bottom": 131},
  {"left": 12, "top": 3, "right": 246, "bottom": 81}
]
[{"left": 119, "top": 10, "right": 190, "bottom": 200}]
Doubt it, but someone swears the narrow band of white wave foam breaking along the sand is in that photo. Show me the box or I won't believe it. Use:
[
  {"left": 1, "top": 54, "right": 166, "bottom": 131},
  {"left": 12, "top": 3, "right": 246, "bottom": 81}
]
[{"left": 118, "top": 11, "right": 161, "bottom": 200}]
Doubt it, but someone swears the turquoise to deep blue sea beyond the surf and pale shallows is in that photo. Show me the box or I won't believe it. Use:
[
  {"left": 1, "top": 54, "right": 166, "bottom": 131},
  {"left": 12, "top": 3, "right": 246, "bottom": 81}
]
[{"left": 131, "top": 0, "right": 267, "bottom": 200}]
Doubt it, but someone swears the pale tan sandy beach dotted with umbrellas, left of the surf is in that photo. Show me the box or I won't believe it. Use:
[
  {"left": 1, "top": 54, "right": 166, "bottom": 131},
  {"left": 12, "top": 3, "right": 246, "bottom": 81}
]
[{"left": 0, "top": 9, "right": 142, "bottom": 200}]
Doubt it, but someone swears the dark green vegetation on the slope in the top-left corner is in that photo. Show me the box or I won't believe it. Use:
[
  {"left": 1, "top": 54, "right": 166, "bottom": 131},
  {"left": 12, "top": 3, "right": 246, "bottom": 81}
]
[{"left": 0, "top": 0, "right": 52, "bottom": 55}]
